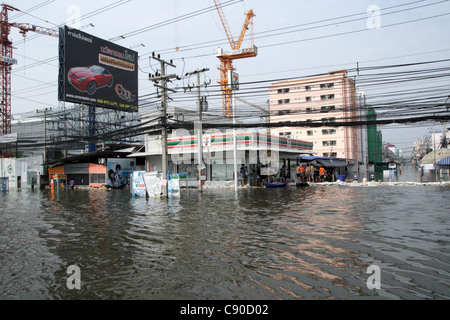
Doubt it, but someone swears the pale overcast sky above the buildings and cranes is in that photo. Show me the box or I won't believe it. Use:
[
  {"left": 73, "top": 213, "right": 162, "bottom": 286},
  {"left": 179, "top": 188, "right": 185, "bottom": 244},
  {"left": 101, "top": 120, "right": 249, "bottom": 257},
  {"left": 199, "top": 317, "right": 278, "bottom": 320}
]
[{"left": 6, "top": 0, "right": 450, "bottom": 152}]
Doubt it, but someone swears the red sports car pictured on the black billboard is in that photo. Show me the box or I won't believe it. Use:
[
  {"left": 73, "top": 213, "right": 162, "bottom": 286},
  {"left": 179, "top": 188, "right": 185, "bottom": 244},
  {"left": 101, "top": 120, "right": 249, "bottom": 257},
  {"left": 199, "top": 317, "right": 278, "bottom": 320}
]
[{"left": 68, "top": 65, "right": 113, "bottom": 95}]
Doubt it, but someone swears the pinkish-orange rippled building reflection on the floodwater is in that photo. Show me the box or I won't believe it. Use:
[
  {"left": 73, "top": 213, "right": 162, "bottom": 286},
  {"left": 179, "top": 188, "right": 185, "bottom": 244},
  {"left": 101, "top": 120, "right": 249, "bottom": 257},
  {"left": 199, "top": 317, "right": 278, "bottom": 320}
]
[{"left": 229, "top": 188, "right": 361, "bottom": 298}]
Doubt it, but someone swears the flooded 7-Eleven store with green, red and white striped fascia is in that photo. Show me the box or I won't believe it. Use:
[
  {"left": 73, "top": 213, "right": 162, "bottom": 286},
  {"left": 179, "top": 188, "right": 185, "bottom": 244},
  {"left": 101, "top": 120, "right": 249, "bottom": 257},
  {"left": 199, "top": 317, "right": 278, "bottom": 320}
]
[{"left": 129, "top": 130, "right": 313, "bottom": 186}]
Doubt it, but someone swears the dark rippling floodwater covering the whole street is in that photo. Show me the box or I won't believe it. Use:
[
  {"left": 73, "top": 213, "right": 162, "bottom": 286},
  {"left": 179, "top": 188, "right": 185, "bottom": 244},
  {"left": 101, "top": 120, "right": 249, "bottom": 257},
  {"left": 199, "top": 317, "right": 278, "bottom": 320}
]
[{"left": 0, "top": 172, "right": 450, "bottom": 300}]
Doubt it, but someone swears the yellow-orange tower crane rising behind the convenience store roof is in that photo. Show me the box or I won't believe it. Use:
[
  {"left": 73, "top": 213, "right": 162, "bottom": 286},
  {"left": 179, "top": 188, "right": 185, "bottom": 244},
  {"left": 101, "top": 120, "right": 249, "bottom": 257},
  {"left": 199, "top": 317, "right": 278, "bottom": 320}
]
[{"left": 214, "top": 0, "right": 258, "bottom": 118}]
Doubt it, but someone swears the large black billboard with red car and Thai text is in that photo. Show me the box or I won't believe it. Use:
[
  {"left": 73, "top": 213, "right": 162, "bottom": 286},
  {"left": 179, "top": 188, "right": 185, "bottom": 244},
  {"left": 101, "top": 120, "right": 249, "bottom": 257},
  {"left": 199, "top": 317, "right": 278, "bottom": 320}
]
[{"left": 58, "top": 26, "right": 138, "bottom": 112}]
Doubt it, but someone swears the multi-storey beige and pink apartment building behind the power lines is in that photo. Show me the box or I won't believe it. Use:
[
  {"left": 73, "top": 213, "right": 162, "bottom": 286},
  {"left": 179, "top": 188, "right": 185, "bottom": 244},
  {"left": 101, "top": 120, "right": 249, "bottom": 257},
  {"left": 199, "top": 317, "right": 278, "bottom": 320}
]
[{"left": 269, "top": 70, "right": 361, "bottom": 165}]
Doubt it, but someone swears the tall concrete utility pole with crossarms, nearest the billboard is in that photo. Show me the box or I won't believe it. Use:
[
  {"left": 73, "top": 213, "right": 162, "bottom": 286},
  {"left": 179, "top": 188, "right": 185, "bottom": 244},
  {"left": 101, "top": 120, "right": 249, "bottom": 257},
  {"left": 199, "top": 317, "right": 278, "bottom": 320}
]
[{"left": 149, "top": 52, "right": 178, "bottom": 197}]
